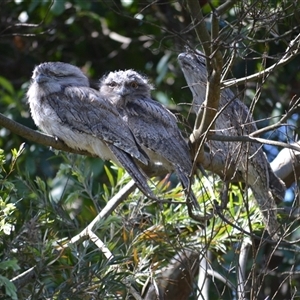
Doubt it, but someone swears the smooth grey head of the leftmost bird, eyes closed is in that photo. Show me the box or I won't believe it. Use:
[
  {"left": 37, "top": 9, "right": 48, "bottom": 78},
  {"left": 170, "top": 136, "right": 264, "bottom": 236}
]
[{"left": 32, "top": 62, "right": 89, "bottom": 94}]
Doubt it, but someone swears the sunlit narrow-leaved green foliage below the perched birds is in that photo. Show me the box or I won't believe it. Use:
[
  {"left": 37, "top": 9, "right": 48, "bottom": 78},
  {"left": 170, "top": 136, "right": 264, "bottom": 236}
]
[{"left": 0, "top": 145, "right": 268, "bottom": 299}]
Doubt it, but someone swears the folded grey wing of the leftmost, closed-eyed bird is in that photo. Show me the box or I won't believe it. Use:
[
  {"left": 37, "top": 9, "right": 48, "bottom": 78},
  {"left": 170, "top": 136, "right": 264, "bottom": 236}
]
[{"left": 47, "top": 87, "right": 148, "bottom": 164}]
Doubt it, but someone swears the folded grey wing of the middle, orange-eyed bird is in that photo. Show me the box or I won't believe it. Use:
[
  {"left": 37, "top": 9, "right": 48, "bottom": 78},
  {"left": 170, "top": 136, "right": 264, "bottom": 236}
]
[{"left": 124, "top": 98, "right": 192, "bottom": 174}]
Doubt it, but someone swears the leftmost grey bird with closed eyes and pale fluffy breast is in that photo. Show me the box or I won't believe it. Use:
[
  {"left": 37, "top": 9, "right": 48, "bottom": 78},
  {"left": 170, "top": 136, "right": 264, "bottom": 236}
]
[{"left": 27, "top": 62, "right": 155, "bottom": 198}]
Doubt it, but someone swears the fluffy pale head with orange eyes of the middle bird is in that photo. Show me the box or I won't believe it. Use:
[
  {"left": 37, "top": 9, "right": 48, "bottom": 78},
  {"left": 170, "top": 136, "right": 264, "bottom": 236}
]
[{"left": 99, "top": 69, "right": 153, "bottom": 104}]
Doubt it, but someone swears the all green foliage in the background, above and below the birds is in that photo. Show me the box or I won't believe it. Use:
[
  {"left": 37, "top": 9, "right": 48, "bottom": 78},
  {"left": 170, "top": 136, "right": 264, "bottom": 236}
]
[{"left": 0, "top": 0, "right": 300, "bottom": 299}]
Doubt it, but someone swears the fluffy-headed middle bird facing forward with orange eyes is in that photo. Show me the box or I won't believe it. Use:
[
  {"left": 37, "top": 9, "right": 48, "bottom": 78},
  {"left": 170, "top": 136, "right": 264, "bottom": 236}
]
[{"left": 99, "top": 70, "right": 199, "bottom": 212}]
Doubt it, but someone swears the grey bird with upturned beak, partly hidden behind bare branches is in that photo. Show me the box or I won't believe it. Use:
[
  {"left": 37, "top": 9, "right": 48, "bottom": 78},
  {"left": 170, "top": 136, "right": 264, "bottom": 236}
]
[{"left": 178, "top": 51, "right": 285, "bottom": 239}]
